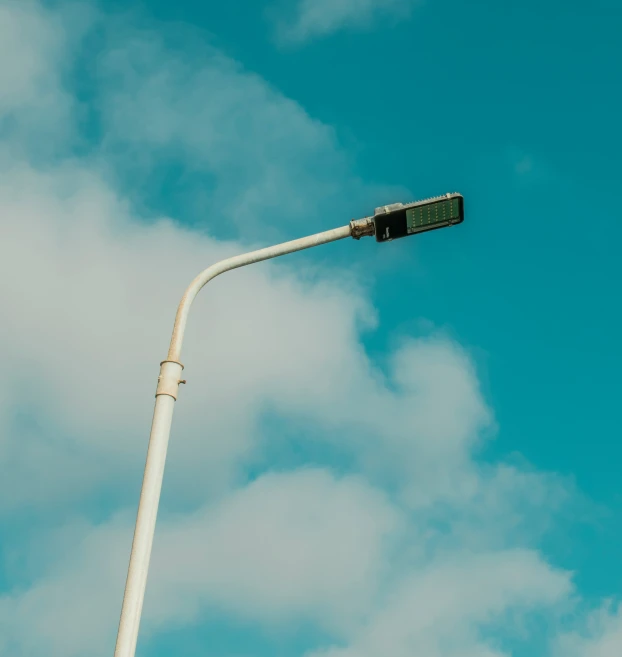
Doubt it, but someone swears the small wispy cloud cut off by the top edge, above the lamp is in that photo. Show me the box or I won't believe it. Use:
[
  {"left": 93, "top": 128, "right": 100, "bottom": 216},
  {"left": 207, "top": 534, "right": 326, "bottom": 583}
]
[{"left": 277, "top": 0, "right": 414, "bottom": 43}]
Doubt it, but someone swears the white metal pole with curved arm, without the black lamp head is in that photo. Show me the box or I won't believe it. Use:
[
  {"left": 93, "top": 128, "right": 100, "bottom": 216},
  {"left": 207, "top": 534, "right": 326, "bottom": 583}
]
[{"left": 114, "top": 218, "right": 374, "bottom": 657}]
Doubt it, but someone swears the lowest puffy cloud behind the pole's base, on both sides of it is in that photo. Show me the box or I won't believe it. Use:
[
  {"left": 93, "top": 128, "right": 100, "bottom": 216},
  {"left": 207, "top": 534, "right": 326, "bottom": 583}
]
[{"left": 0, "top": 470, "right": 401, "bottom": 657}]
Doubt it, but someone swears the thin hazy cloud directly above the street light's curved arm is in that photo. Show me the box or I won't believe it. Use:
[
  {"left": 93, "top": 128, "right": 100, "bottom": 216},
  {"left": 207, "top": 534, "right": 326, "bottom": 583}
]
[{"left": 94, "top": 23, "right": 407, "bottom": 241}]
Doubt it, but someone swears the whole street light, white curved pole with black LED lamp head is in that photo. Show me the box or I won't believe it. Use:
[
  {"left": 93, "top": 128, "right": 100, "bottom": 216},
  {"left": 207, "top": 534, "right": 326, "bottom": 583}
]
[{"left": 114, "top": 194, "right": 464, "bottom": 657}]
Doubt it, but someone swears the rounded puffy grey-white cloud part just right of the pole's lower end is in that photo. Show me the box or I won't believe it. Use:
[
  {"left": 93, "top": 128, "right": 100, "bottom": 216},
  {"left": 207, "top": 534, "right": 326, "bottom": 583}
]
[{"left": 147, "top": 469, "right": 401, "bottom": 629}]
